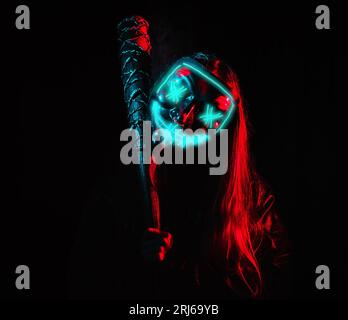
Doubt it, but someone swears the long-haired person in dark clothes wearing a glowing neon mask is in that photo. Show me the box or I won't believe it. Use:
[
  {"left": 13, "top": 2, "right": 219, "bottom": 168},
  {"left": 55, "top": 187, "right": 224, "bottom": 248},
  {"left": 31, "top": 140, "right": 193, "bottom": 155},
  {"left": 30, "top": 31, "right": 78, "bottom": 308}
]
[{"left": 142, "top": 53, "right": 288, "bottom": 298}]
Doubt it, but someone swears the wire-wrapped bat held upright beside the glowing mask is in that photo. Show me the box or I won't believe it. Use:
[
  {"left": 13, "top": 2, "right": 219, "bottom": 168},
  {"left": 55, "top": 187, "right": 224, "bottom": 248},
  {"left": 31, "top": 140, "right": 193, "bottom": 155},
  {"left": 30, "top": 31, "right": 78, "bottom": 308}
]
[{"left": 117, "top": 16, "right": 160, "bottom": 228}]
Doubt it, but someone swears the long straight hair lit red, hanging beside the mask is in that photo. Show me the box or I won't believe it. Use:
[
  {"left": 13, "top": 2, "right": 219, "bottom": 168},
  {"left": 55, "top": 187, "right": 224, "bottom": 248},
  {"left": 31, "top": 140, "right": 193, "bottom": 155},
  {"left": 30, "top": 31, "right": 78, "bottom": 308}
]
[{"left": 150, "top": 53, "right": 272, "bottom": 297}]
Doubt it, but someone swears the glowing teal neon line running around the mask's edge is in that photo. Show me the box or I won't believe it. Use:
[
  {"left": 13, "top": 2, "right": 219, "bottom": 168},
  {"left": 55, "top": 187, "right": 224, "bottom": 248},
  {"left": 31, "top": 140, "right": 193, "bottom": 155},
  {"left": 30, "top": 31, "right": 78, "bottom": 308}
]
[{"left": 150, "top": 58, "right": 236, "bottom": 145}]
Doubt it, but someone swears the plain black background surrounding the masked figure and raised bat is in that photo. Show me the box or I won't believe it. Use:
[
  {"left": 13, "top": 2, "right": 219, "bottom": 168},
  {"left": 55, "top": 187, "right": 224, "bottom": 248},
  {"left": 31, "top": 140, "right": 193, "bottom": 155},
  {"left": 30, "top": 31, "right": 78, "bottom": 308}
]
[{"left": 2, "top": 1, "right": 348, "bottom": 299}]
